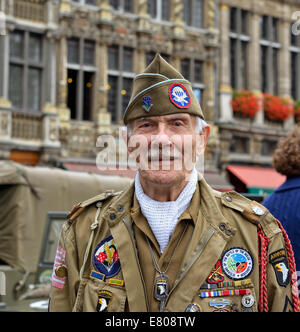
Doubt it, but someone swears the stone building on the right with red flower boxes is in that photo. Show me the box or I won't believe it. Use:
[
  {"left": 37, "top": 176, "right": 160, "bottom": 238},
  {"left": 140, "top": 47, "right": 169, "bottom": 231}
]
[{"left": 216, "top": 0, "right": 300, "bottom": 195}]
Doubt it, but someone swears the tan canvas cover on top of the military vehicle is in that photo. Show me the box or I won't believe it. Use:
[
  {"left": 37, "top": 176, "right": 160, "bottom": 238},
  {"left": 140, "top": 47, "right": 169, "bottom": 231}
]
[{"left": 0, "top": 161, "right": 132, "bottom": 272}]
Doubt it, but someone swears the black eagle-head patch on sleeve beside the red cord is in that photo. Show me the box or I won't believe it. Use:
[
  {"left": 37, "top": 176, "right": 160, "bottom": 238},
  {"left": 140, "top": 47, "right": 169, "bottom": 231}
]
[{"left": 269, "top": 249, "right": 291, "bottom": 287}]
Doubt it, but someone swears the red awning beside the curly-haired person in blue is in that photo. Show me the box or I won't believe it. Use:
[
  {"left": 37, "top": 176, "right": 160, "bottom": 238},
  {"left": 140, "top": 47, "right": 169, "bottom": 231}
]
[{"left": 227, "top": 165, "right": 286, "bottom": 195}]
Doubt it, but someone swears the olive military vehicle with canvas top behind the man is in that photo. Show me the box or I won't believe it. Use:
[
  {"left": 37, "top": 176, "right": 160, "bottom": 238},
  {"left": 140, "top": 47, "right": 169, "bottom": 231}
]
[{"left": 0, "top": 161, "right": 132, "bottom": 311}]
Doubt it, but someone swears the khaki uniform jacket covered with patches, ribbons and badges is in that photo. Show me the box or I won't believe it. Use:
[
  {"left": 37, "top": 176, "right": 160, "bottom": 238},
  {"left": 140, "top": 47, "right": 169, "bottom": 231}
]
[{"left": 49, "top": 175, "right": 297, "bottom": 312}]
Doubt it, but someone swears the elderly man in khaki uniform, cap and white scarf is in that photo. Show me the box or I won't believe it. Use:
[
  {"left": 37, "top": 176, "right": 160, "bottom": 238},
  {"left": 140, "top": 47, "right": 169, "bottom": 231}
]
[{"left": 50, "top": 55, "right": 299, "bottom": 312}]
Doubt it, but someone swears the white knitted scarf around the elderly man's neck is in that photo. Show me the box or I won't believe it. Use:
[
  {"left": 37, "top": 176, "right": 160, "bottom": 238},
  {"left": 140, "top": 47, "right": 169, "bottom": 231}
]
[{"left": 135, "top": 169, "right": 198, "bottom": 253}]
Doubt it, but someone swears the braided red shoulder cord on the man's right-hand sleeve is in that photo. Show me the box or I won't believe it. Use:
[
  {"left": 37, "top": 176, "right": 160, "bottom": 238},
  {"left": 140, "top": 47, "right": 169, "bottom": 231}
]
[{"left": 258, "top": 219, "right": 300, "bottom": 312}]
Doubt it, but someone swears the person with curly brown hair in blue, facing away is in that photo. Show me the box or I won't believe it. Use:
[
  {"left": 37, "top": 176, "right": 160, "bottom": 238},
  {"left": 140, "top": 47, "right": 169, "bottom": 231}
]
[{"left": 263, "top": 126, "right": 300, "bottom": 271}]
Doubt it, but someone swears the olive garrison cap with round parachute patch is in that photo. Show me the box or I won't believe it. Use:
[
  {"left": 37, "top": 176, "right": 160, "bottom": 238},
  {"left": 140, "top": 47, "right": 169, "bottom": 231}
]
[{"left": 123, "top": 54, "right": 204, "bottom": 125}]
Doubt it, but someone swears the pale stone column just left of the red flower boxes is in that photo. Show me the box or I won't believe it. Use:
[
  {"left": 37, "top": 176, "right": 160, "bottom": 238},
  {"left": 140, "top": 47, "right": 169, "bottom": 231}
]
[{"left": 219, "top": 4, "right": 233, "bottom": 122}]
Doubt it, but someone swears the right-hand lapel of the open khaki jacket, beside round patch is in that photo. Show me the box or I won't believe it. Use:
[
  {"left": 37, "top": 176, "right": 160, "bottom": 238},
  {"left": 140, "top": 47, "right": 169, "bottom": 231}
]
[{"left": 166, "top": 179, "right": 235, "bottom": 311}]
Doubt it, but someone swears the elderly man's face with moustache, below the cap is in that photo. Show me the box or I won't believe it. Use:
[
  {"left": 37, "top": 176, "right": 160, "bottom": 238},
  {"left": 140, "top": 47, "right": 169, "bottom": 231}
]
[{"left": 127, "top": 113, "right": 207, "bottom": 185}]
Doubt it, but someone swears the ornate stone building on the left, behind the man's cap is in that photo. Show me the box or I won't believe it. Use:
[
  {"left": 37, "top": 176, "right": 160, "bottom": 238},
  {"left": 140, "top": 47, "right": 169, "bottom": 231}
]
[{"left": 0, "top": 0, "right": 218, "bottom": 170}]
